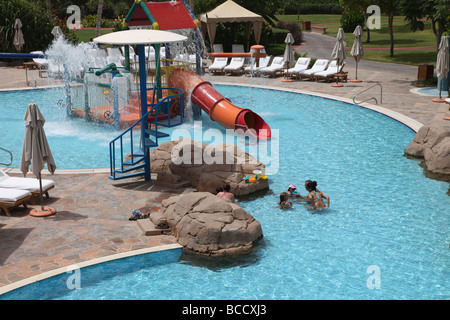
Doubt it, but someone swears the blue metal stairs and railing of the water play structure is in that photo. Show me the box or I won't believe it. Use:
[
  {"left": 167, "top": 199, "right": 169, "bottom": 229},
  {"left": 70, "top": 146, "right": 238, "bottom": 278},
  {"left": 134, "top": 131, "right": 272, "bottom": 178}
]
[{"left": 109, "top": 88, "right": 184, "bottom": 180}]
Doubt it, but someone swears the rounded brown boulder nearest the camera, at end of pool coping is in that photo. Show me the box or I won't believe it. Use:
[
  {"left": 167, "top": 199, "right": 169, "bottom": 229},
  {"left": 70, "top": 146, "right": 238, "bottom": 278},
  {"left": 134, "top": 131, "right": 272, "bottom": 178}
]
[{"left": 161, "top": 192, "right": 262, "bottom": 256}]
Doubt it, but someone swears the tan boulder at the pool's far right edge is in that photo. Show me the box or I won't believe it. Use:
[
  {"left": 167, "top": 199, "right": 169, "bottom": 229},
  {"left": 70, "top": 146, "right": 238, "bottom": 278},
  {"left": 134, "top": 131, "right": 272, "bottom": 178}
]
[{"left": 405, "top": 123, "right": 450, "bottom": 175}]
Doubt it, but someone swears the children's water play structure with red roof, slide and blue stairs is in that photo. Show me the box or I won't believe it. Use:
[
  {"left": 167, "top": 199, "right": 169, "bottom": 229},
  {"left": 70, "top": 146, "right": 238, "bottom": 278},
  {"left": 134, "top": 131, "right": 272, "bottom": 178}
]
[{"left": 1, "top": 0, "right": 271, "bottom": 181}]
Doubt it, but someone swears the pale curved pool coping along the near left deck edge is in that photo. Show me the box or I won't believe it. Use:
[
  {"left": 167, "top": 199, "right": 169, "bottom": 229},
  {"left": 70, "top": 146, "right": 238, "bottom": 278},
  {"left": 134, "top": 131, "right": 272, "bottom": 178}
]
[{"left": 0, "top": 243, "right": 183, "bottom": 296}]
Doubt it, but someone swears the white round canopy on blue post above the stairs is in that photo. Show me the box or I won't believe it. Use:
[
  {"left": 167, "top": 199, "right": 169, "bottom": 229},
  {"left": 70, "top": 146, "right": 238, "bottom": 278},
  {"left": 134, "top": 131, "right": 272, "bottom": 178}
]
[{"left": 94, "top": 29, "right": 187, "bottom": 45}]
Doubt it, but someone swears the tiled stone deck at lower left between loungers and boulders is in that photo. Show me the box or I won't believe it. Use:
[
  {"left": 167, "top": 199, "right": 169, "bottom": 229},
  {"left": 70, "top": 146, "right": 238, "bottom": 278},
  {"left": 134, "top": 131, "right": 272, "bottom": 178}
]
[{"left": 0, "top": 171, "right": 182, "bottom": 287}]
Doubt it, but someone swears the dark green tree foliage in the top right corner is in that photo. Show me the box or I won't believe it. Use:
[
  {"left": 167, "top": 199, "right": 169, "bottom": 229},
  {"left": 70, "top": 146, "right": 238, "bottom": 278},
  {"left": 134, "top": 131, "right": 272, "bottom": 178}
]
[{"left": 401, "top": 0, "right": 450, "bottom": 47}]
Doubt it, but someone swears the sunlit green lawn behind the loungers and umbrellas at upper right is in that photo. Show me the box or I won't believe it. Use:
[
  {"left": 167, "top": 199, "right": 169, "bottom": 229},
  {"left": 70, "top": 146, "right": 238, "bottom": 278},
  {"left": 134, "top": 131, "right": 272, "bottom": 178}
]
[{"left": 277, "top": 14, "right": 437, "bottom": 65}]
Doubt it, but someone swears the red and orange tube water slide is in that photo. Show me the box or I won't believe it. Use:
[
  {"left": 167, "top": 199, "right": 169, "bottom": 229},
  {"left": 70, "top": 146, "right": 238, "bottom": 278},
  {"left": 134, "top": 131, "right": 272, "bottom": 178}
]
[{"left": 169, "top": 69, "right": 271, "bottom": 140}]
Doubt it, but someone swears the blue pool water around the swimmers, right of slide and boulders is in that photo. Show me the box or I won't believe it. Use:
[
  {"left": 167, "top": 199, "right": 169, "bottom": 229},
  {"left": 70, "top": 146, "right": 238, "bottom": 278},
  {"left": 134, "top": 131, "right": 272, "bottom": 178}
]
[{"left": 0, "top": 86, "right": 450, "bottom": 299}]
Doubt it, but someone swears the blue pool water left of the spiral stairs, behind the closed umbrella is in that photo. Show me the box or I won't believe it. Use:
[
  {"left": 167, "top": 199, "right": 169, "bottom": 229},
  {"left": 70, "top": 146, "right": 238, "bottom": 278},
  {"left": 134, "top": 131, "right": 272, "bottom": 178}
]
[{"left": 0, "top": 89, "right": 120, "bottom": 169}]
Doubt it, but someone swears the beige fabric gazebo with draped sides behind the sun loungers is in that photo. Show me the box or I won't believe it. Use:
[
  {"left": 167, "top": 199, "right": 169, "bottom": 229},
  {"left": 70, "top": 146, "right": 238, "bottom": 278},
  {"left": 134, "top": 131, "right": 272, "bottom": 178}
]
[{"left": 200, "top": 0, "right": 264, "bottom": 50}]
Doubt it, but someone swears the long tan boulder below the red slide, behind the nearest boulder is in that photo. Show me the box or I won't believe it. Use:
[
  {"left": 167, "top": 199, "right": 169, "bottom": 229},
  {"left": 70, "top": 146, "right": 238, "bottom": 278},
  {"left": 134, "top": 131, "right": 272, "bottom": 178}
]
[{"left": 150, "top": 138, "right": 269, "bottom": 197}]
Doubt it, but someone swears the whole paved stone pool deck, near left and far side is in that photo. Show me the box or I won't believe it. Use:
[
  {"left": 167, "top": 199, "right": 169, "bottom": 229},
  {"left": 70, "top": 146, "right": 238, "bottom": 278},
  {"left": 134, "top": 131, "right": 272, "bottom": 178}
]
[{"left": 0, "top": 32, "right": 450, "bottom": 290}]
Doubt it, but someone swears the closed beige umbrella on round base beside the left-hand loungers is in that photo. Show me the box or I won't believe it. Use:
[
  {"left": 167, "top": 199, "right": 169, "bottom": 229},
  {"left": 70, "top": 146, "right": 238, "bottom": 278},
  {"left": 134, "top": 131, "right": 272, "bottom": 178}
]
[{"left": 20, "top": 103, "right": 56, "bottom": 216}]
